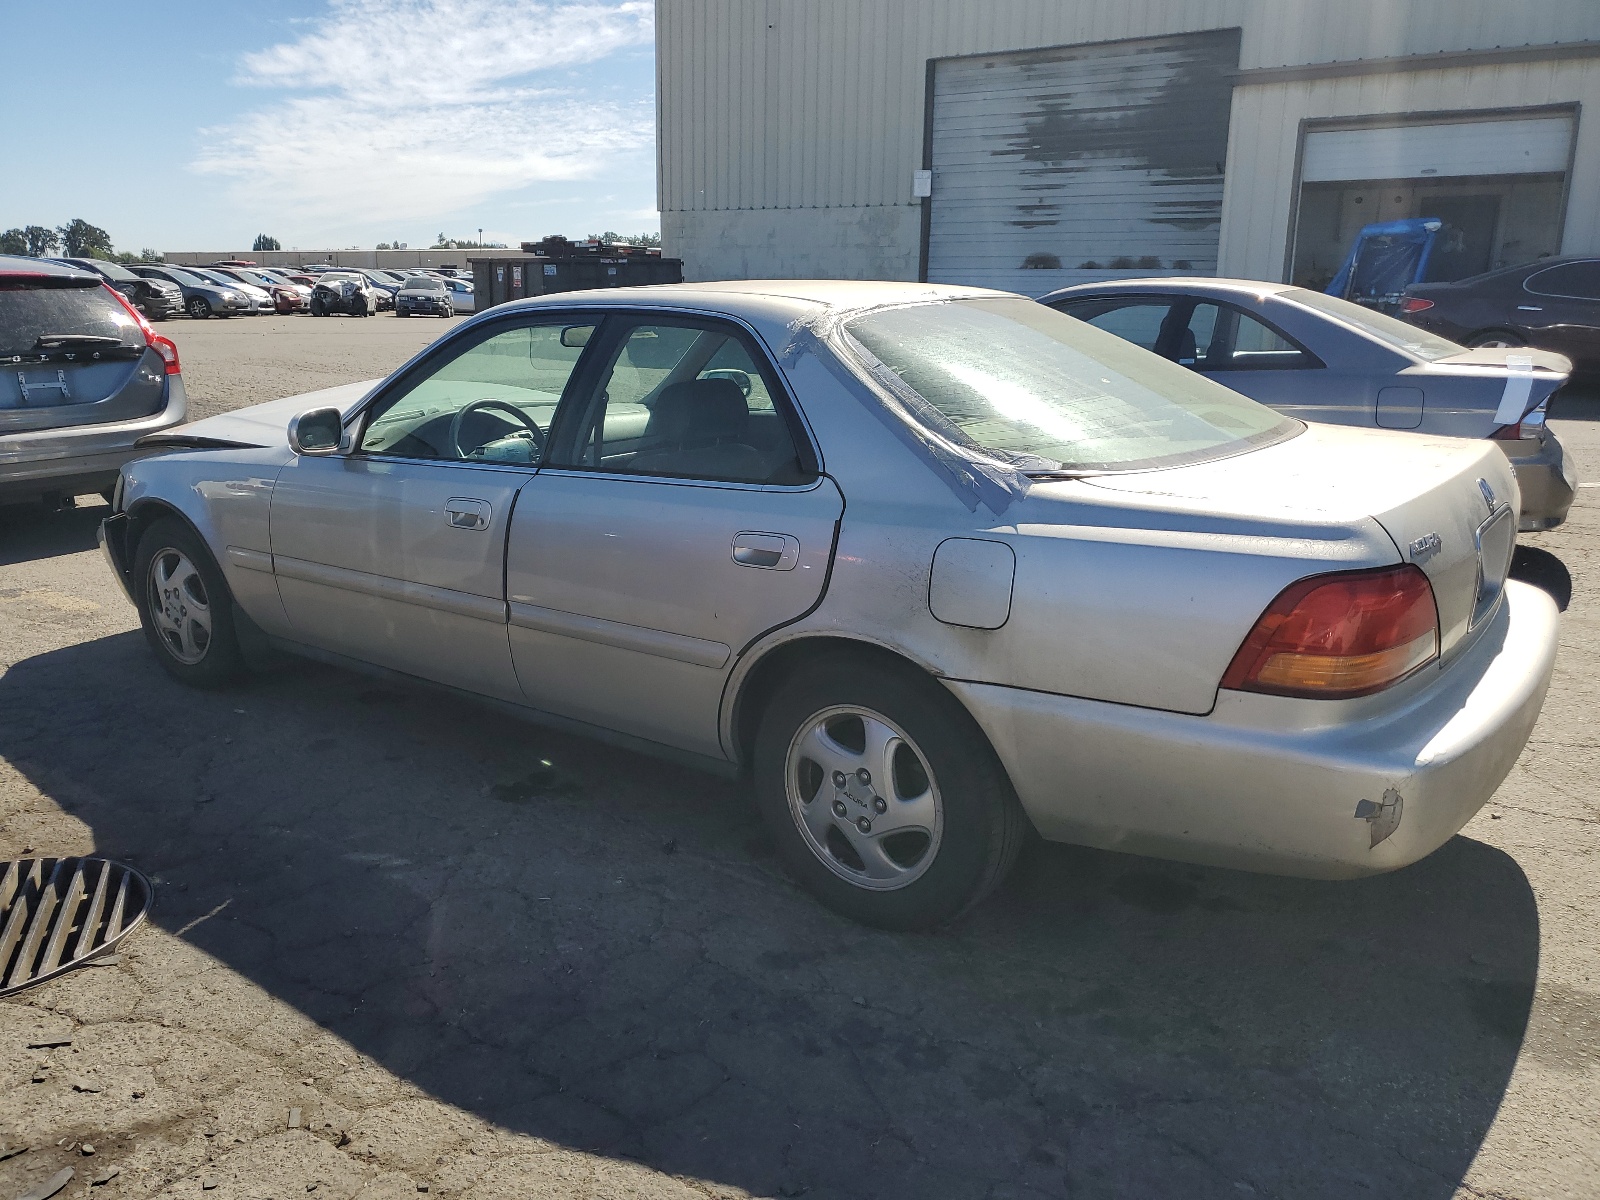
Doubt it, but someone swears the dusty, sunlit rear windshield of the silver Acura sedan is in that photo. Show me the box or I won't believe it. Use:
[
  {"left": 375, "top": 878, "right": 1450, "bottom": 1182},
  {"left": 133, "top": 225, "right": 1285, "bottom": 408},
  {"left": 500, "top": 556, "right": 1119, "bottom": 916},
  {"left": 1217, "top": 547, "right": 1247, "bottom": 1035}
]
[{"left": 845, "top": 298, "right": 1304, "bottom": 474}]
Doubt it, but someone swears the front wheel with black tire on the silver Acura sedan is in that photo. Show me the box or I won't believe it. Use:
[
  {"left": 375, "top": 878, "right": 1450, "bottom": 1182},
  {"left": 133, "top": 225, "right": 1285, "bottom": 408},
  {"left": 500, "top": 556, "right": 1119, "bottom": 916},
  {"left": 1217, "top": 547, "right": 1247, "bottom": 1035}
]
[{"left": 133, "top": 517, "right": 245, "bottom": 688}]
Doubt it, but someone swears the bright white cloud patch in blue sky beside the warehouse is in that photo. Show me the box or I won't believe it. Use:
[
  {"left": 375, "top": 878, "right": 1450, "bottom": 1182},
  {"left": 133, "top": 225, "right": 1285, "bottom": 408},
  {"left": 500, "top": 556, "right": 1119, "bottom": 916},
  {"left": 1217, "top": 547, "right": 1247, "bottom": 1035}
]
[{"left": 194, "top": 0, "right": 654, "bottom": 227}]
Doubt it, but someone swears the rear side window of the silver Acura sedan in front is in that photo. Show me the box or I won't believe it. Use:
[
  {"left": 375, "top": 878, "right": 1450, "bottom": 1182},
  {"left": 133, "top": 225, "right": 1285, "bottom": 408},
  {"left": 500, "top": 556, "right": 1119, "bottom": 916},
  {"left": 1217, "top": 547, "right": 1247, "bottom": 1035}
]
[{"left": 565, "top": 320, "right": 811, "bottom": 483}]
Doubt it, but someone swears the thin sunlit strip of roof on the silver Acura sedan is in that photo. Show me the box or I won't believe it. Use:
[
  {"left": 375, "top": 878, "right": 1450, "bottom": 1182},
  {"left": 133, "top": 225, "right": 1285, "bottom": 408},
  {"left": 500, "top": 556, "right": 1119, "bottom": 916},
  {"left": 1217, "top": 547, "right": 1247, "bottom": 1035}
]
[{"left": 508, "top": 278, "right": 1016, "bottom": 312}]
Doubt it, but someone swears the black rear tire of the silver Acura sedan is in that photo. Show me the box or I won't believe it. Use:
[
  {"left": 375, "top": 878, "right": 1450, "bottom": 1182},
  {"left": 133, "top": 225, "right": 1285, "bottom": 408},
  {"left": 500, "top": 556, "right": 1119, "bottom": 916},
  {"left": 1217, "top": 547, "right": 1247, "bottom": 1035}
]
[{"left": 752, "top": 654, "right": 1029, "bottom": 930}]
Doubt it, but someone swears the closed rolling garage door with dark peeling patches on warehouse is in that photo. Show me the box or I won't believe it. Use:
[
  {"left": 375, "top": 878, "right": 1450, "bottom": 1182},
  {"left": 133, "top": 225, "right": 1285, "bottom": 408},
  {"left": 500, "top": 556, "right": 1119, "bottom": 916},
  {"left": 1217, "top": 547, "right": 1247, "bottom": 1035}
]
[{"left": 928, "top": 29, "right": 1238, "bottom": 296}]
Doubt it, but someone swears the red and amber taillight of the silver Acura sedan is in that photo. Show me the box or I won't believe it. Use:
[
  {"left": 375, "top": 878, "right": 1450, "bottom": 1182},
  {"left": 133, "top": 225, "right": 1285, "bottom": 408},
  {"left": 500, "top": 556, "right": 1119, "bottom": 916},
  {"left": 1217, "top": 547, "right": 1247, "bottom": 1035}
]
[{"left": 1222, "top": 565, "right": 1438, "bottom": 699}]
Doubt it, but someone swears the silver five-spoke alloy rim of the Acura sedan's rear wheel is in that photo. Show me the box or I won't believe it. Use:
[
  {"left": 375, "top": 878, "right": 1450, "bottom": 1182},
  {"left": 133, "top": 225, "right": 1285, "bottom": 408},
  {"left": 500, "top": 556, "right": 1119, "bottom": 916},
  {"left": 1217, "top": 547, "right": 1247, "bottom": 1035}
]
[{"left": 784, "top": 706, "right": 944, "bottom": 891}]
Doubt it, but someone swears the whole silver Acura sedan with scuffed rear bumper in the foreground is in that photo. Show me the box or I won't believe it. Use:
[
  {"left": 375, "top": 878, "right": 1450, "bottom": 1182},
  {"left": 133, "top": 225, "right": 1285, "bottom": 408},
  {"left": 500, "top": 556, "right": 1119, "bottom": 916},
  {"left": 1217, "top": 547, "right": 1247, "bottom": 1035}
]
[{"left": 102, "top": 282, "right": 1557, "bottom": 928}]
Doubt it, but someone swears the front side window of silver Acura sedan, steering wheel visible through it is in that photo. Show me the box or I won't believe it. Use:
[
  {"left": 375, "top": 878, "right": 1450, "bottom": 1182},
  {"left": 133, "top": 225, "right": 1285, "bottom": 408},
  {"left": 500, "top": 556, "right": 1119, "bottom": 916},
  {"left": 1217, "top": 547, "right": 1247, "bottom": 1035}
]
[{"left": 360, "top": 323, "right": 594, "bottom": 464}]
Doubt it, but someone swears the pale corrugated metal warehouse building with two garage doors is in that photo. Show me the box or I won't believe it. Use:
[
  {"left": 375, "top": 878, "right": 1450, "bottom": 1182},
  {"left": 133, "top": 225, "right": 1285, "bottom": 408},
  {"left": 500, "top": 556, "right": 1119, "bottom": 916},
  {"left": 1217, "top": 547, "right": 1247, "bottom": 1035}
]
[{"left": 656, "top": 0, "right": 1600, "bottom": 294}]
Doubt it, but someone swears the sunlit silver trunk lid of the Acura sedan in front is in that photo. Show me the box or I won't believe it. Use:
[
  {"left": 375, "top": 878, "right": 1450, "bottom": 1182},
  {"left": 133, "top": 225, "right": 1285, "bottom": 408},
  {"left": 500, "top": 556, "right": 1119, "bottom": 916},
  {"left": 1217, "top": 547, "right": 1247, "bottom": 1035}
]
[{"left": 1086, "top": 424, "right": 1518, "bottom": 659}]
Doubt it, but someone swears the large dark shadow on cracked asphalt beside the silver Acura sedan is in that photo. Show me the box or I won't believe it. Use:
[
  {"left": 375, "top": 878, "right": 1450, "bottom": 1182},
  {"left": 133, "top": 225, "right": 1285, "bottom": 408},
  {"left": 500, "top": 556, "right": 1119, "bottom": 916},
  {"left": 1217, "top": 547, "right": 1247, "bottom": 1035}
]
[{"left": 0, "top": 634, "right": 1539, "bottom": 1200}]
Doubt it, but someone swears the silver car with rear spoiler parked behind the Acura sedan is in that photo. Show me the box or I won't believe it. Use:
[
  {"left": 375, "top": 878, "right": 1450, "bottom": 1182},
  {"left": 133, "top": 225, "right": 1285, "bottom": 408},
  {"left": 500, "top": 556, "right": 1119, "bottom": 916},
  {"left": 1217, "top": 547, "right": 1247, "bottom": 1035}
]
[{"left": 1040, "top": 278, "right": 1578, "bottom": 531}]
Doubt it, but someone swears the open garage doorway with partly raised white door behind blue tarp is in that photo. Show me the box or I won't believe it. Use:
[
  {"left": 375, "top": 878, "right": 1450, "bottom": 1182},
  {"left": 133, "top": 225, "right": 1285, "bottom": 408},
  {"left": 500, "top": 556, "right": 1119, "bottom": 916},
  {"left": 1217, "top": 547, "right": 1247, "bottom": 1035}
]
[{"left": 1290, "top": 110, "right": 1576, "bottom": 291}]
